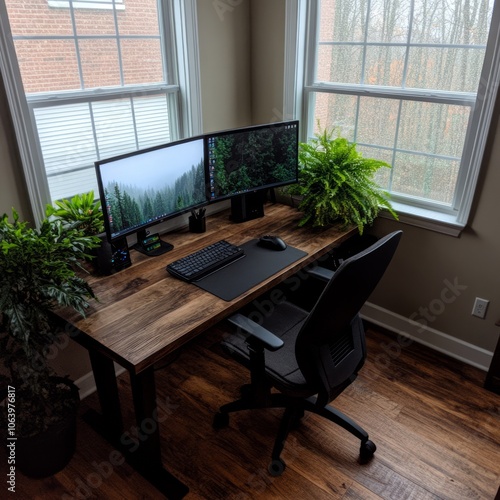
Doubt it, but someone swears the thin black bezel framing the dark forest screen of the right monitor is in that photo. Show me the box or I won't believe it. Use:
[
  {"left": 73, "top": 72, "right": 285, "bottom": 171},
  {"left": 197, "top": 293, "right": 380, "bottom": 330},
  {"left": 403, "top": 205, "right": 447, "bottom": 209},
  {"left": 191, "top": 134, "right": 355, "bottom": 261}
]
[{"left": 205, "top": 120, "right": 300, "bottom": 204}]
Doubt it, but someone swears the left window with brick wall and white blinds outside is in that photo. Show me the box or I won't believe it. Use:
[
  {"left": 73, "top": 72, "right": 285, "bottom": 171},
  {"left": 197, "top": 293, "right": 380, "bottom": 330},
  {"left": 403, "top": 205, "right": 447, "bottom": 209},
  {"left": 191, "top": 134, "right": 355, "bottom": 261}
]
[{"left": 0, "top": 0, "right": 201, "bottom": 220}]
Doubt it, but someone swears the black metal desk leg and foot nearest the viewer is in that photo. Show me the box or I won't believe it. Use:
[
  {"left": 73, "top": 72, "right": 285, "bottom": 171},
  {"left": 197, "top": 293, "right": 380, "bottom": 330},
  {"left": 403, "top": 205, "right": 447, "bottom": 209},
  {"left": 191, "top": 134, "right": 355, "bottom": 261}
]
[{"left": 130, "top": 367, "right": 189, "bottom": 499}]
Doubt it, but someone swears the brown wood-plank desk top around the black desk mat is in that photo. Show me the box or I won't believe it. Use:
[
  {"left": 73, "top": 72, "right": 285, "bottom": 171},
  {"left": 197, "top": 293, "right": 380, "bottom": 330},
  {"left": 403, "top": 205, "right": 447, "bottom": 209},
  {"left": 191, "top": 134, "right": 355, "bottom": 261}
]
[{"left": 58, "top": 204, "right": 356, "bottom": 373}]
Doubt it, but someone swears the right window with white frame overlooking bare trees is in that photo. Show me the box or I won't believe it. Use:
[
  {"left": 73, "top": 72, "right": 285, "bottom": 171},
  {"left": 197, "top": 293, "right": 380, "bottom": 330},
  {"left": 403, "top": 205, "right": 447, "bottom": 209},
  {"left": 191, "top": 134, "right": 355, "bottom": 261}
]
[{"left": 287, "top": 0, "right": 498, "bottom": 234}]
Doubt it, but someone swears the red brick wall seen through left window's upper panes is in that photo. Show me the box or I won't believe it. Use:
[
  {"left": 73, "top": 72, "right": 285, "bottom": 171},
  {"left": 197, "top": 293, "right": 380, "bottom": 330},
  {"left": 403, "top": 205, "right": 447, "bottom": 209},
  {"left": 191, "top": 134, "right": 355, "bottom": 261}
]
[{"left": 6, "top": 0, "right": 163, "bottom": 94}]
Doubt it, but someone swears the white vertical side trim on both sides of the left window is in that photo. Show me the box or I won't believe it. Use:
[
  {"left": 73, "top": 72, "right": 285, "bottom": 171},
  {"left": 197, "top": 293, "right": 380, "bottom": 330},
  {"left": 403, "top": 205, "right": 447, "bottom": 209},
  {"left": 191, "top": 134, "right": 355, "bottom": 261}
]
[{"left": 0, "top": 0, "right": 202, "bottom": 224}]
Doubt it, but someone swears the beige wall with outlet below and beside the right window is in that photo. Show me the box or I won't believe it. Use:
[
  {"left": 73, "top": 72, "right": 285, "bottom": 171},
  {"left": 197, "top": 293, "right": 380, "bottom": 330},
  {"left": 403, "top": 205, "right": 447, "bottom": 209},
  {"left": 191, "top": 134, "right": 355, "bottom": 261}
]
[{"left": 371, "top": 115, "right": 500, "bottom": 351}]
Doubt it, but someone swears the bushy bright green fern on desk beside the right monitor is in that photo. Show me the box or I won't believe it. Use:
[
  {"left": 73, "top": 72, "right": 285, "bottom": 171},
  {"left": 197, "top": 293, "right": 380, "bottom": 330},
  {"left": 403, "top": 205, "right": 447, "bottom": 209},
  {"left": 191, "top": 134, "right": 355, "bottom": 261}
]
[{"left": 288, "top": 129, "right": 397, "bottom": 234}]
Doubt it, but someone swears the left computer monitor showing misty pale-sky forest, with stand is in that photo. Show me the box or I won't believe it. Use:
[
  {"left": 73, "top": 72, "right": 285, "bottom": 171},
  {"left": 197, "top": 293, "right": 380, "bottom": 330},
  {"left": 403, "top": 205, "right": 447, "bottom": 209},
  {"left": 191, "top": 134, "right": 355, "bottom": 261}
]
[{"left": 95, "top": 136, "right": 207, "bottom": 255}]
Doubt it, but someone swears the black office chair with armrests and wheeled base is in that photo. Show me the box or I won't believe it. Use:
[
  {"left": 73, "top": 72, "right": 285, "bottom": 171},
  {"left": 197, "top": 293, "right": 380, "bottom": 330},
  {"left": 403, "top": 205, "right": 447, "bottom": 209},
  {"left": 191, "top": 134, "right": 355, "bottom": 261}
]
[{"left": 213, "top": 231, "right": 402, "bottom": 476}]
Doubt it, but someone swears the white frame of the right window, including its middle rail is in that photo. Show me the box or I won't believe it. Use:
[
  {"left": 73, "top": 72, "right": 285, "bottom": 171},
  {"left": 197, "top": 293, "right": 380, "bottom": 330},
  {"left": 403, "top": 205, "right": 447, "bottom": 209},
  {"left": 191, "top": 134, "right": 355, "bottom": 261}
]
[{"left": 284, "top": 0, "right": 500, "bottom": 236}]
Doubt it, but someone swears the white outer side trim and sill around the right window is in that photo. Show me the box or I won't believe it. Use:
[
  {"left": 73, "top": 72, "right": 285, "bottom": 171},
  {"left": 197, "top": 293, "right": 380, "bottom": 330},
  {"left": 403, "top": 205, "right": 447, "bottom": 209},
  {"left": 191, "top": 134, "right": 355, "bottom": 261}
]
[{"left": 283, "top": 0, "right": 500, "bottom": 236}]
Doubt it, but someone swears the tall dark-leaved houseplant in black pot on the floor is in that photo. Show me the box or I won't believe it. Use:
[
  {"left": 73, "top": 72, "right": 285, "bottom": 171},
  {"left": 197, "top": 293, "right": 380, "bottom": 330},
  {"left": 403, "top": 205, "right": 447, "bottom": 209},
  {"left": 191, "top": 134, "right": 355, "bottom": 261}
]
[{"left": 0, "top": 206, "right": 99, "bottom": 477}]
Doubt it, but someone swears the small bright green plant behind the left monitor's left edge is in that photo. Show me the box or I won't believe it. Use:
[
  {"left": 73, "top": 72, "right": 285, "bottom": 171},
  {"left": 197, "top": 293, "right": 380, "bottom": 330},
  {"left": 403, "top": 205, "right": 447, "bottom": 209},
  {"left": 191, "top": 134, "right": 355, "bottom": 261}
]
[{"left": 47, "top": 191, "right": 104, "bottom": 236}]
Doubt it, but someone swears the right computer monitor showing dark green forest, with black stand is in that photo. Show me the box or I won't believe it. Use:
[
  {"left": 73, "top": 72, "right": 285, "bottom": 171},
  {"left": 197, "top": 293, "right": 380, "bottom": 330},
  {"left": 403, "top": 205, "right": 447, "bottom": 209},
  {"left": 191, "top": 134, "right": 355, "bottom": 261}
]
[{"left": 205, "top": 120, "right": 299, "bottom": 221}]
